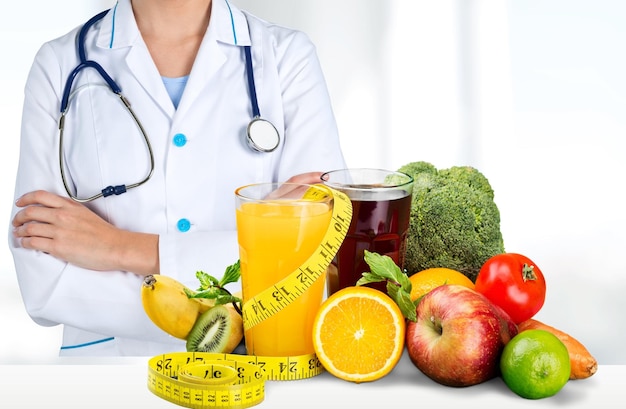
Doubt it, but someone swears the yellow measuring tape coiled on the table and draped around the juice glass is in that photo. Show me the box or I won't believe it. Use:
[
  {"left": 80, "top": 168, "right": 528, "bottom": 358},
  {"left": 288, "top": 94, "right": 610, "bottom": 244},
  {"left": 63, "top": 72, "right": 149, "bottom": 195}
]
[{"left": 148, "top": 184, "right": 352, "bottom": 409}]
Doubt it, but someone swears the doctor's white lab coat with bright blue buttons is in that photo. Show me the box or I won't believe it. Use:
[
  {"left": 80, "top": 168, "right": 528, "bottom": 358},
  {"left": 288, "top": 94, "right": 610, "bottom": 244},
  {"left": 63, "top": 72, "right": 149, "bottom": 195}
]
[{"left": 9, "top": 0, "right": 345, "bottom": 355}]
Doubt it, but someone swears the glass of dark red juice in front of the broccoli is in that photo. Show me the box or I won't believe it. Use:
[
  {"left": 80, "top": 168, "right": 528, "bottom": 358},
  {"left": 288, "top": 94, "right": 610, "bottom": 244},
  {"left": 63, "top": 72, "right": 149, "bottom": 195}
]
[{"left": 321, "top": 168, "right": 413, "bottom": 295}]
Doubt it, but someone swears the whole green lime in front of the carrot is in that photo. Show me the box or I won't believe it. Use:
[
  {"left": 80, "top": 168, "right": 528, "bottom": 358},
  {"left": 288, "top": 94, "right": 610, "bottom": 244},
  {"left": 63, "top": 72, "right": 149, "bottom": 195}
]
[{"left": 500, "top": 329, "right": 570, "bottom": 399}]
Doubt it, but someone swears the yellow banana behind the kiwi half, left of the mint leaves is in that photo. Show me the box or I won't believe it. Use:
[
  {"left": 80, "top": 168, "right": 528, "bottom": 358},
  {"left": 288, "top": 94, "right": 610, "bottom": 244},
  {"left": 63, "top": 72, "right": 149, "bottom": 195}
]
[{"left": 141, "top": 274, "right": 214, "bottom": 339}]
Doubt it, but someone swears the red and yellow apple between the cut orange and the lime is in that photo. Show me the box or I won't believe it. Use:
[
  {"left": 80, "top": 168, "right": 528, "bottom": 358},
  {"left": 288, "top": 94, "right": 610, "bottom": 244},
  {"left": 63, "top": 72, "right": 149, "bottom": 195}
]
[{"left": 406, "top": 284, "right": 517, "bottom": 386}]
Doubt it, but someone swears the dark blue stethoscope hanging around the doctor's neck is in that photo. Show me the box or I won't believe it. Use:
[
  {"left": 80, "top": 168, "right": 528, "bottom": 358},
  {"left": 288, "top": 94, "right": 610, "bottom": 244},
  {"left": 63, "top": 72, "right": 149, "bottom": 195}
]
[{"left": 59, "top": 10, "right": 280, "bottom": 203}]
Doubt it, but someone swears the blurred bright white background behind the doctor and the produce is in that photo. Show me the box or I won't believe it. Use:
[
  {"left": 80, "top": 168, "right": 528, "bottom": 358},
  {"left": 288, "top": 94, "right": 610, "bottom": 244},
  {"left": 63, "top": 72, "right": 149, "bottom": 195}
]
[{"left": 0, "top": 0, "right": 626, "bottom": 364}]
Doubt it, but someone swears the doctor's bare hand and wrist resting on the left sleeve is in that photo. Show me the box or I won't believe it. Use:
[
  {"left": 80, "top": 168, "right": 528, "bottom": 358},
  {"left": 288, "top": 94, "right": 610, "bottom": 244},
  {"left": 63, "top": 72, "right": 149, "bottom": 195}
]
[{"left": 12, "top": 190, "right": 158, "bottom": 275}]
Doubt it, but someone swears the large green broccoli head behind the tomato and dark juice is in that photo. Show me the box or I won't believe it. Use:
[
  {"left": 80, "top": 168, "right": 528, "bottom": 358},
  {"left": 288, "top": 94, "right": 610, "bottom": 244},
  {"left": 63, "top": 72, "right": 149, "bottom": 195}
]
[{"left": 399, "top": 162, "right": 504, "bottom": 281}]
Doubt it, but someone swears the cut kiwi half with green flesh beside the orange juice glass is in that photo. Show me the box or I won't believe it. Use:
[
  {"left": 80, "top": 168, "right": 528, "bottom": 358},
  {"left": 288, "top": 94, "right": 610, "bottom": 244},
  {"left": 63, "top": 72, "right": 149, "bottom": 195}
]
[{"left": 187, "top": 305, "right": 232, "bottom": 352}]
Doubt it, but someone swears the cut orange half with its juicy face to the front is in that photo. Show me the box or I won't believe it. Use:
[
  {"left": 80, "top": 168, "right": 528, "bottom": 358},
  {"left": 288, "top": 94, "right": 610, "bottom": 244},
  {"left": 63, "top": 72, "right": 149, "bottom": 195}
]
[{"left": 313, "top": 286, "right": 406, "bottom": 383}]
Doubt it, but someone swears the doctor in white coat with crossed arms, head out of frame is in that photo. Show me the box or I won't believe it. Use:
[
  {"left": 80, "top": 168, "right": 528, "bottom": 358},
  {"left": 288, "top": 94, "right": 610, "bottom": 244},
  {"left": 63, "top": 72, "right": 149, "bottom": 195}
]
[{"left": 9, "top": 0, "right": 345, "bottom": 355}]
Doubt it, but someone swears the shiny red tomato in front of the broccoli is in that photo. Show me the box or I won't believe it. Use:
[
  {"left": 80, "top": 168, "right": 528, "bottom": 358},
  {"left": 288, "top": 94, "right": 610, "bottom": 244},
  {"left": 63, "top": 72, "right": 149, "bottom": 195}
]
[{"left": 474, "top": 253, "right": 546, "bottom": 324}]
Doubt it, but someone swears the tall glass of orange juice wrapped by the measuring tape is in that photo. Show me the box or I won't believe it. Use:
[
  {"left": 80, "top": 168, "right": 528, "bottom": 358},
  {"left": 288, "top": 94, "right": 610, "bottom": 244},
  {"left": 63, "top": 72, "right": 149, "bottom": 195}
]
[{"left": 235, "top": 183, "right": 334, "bottom": 356}]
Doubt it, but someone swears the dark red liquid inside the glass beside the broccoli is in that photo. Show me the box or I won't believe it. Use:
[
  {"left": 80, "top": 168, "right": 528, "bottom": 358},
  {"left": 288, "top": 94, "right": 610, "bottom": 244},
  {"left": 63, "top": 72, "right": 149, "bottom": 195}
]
[{"left": 327, "top": 190, "right": 411, "bottom": 295}]
